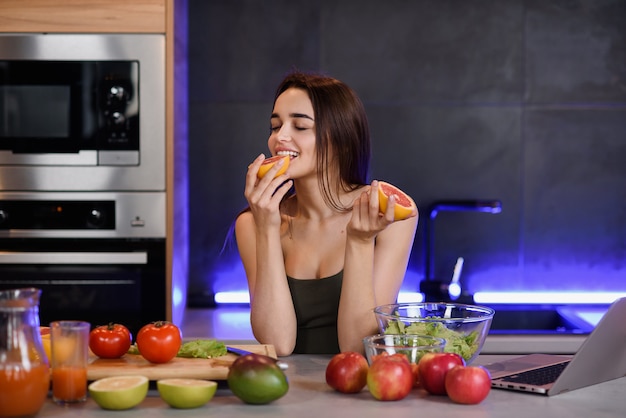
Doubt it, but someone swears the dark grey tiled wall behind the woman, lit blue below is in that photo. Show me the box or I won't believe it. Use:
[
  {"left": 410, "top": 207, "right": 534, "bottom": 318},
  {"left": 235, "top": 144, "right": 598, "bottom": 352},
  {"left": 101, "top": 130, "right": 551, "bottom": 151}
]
[{"left": 189, "top": 0, "right": 626, "bottom": 299}]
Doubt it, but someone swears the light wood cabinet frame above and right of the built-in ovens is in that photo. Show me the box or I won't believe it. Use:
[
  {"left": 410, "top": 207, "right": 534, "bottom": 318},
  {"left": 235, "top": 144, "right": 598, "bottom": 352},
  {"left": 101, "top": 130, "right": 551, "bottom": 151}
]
[{"left": 0, "top": 0, "right": 186, "bottom": 323}]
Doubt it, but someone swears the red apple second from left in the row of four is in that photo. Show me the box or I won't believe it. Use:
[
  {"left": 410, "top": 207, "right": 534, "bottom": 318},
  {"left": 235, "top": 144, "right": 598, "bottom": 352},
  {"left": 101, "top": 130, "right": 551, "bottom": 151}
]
[{"left": 367, "top": 355, "right": 415, "bottom": 401}]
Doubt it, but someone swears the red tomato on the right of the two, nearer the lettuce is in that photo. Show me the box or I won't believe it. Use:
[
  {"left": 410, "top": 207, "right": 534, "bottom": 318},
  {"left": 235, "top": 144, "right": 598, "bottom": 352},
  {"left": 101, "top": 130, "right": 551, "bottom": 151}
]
[{"left": 137, "top": 321, "right": 183, "bottom": 363}]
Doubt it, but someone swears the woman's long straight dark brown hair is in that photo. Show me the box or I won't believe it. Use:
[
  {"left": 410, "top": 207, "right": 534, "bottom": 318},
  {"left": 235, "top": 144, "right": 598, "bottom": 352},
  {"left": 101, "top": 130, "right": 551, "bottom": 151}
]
[{"left": 274, "top": 72, "right": 371, "bottom": 210}]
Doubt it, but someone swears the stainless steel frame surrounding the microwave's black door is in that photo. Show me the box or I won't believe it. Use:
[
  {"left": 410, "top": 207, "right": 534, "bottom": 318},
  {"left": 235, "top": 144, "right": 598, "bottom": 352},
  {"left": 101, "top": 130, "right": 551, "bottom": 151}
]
[{"left": 0, "top": 34, "right": 166, "bottom": 191}]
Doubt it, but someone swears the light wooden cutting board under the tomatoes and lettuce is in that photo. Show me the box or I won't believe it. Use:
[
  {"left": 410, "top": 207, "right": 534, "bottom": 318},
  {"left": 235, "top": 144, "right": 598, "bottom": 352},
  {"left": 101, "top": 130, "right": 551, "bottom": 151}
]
[{"left": 87, "top": 344, "right": 277, "bottom": 380}]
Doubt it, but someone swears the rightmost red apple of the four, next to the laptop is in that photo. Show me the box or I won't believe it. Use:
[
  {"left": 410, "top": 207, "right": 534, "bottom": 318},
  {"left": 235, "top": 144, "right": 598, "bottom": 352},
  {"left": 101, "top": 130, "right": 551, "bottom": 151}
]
[{"left": 445, "top": 366, "right": 491, "bottom": 405}]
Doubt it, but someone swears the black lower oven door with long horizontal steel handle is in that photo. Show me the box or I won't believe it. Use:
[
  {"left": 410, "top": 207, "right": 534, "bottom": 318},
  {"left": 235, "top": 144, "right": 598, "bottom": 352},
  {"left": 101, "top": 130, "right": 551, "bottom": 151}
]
[{"left": 0, "top": 238, "right": 167, "bottom": 335}]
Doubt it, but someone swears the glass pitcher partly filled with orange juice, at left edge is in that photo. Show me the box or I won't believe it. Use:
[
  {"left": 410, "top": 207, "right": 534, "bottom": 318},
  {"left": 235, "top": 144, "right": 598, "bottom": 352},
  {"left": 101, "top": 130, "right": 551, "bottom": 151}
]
[{"left": 0, "top": 288, "right": 50, "bottom": 418}]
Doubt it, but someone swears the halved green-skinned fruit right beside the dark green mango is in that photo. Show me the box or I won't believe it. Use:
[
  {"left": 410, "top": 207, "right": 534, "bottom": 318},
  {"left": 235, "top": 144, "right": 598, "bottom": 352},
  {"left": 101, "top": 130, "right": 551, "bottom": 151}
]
[{"left": 157, "top": 379, "right": 217, "bottom": 409}]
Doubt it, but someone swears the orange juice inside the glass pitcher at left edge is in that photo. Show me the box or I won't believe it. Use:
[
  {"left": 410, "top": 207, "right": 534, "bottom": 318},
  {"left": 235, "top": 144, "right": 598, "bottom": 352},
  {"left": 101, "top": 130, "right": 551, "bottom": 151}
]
[{"left": 0, "top": 363, "right": 50, "bottom": 417}]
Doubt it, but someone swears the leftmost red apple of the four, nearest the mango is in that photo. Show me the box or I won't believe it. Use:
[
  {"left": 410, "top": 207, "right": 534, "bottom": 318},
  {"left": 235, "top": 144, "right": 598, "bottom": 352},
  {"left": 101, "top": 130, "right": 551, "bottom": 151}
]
[{"left": 326, "top": 351, "right": 369, "bottom": 393}]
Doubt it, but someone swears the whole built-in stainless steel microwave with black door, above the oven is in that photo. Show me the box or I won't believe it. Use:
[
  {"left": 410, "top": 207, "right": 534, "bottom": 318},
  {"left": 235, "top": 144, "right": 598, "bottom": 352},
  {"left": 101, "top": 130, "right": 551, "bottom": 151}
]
[{"left": 0, "top": 33, "right": 166, "bottom": 191}]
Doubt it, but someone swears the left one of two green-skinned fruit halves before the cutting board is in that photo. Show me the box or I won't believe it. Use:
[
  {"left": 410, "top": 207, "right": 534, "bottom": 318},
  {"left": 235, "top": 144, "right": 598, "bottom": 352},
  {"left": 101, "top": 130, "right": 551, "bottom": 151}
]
[{"left": 89, "top": 376, "right": 148, "bottom": 410}]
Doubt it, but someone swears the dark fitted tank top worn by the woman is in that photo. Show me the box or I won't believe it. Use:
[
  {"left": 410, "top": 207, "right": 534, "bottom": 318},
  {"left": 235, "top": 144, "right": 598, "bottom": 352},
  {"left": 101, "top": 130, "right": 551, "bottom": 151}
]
[{"left": 287, "top": 270, "right": 343, "bottom": 354}]
